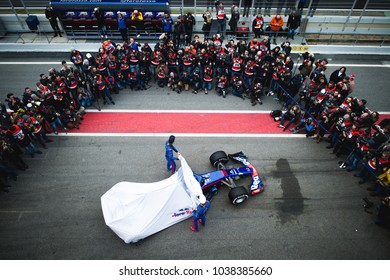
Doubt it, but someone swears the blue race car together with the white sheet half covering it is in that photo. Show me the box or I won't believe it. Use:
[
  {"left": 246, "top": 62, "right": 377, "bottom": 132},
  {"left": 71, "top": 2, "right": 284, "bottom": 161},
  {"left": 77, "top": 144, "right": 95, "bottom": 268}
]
[{"left": 101, "top": 151, "right": 264, "bottom": 243}]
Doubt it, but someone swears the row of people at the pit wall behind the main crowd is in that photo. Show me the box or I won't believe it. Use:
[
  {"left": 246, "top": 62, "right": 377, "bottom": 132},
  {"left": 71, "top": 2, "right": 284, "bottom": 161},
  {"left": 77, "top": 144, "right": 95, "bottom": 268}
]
[{"left": 87, "top": 1, "right": 301, "bottom": 47}]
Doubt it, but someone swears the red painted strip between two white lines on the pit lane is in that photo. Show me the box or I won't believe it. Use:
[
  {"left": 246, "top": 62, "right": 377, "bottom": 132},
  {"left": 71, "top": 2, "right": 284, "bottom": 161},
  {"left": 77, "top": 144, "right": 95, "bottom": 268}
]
[{"left": 72, "top": 111, "right": 390, "bottom": 134}]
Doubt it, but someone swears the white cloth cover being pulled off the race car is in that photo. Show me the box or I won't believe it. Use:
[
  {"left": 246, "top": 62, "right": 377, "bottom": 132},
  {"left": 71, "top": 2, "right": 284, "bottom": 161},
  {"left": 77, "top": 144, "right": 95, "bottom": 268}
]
[{"left": 101, "top": 156, "right": 203, "bottom": 243}]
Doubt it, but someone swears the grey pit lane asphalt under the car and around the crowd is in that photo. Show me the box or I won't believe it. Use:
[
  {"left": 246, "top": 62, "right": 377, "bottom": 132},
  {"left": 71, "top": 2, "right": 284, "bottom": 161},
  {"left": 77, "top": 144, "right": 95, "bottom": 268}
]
[{"left": 0, "top": 54, "right": 390, "bottom": 260}]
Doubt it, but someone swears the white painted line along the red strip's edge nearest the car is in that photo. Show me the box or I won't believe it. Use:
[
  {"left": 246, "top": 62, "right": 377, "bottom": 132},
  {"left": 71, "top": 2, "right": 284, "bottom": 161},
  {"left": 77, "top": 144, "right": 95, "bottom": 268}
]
[{"left": 50, "top": 131, "right": 306, "bottom": 138}]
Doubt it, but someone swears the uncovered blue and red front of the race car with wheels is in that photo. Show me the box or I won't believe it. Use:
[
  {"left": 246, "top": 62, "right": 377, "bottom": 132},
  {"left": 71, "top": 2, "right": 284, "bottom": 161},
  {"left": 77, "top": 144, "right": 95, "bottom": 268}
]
[{"left": 194, "top": 151, "right": 264, "bottom": 204}]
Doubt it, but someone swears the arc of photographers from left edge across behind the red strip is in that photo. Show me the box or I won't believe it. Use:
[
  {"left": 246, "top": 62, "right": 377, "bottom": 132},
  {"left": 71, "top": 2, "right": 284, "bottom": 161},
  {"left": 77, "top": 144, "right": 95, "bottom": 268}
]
[{"left": 0, "top": 25, "right": 288, "bottom": 191}]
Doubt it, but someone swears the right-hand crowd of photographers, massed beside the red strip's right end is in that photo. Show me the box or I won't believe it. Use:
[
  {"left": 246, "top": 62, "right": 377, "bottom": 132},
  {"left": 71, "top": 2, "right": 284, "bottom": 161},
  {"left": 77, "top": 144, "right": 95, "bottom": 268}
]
[{"left": 271, "top": 53, "right": 390, "bottom": 199}]
